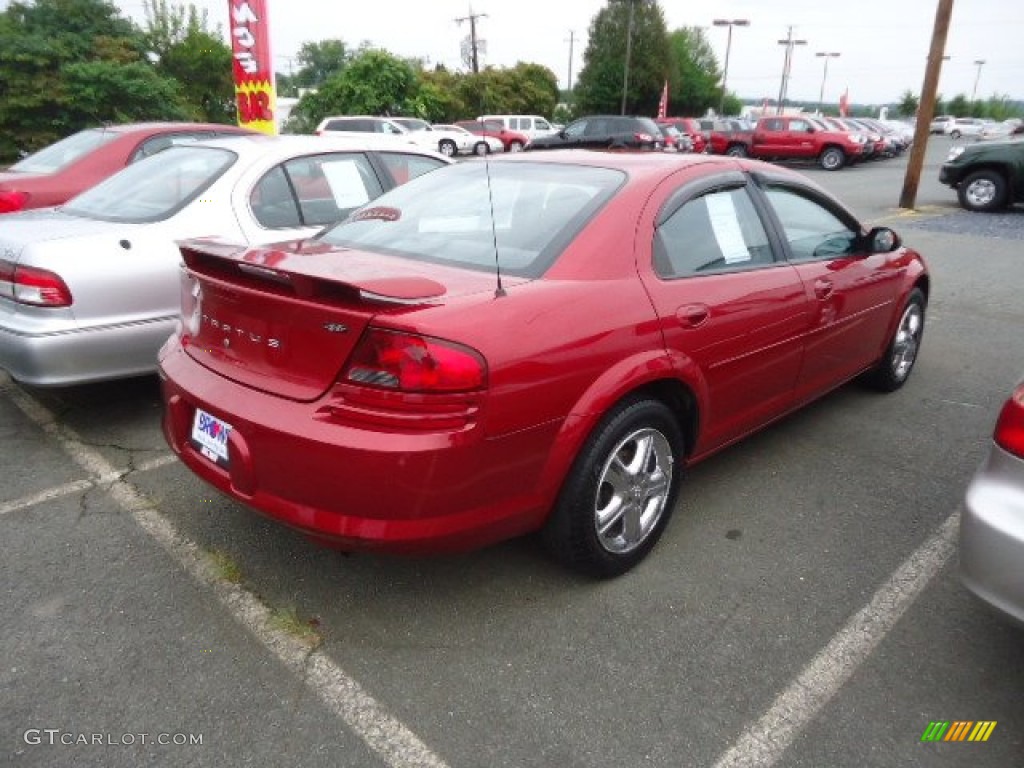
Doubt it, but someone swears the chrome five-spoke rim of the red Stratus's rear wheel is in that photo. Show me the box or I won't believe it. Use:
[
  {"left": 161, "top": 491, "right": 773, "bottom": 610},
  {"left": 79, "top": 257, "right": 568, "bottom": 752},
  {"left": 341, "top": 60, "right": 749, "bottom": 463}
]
[{"left": 594, "top": 427, "right": 673, "bottom": 554}]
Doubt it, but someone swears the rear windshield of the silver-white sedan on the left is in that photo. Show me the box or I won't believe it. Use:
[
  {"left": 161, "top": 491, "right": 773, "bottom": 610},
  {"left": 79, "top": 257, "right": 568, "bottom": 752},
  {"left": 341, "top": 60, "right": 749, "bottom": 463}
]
[{"left": 62, "top": 144, "right": 238, "bottom": 223}]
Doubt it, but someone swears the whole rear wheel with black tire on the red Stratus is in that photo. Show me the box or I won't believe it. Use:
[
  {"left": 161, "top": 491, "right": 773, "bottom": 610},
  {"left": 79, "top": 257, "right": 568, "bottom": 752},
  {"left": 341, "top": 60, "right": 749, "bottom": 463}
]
[{"left": 543, "top": 397, "right": 684, "bottom": 578}]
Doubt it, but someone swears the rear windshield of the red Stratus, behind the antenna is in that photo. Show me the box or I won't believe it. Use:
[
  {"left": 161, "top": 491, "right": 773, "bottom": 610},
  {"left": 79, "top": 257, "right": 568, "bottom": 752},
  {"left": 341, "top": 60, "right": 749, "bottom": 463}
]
[{"left": 319, "top": 163, "right": 626, "bottom": 278}]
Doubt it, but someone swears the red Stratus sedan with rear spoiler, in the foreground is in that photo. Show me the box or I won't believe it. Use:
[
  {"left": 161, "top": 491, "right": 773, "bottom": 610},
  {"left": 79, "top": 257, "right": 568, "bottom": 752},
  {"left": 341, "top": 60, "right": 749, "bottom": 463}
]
[{"left": 159, "top": 151, "right": 930, "bottom": 577}]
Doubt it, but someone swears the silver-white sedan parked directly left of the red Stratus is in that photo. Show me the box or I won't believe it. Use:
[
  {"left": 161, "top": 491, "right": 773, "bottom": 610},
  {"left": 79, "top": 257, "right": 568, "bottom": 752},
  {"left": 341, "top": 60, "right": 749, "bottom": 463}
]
[{"left": 0, "top": 135, "right": 453, "bottom": 386}]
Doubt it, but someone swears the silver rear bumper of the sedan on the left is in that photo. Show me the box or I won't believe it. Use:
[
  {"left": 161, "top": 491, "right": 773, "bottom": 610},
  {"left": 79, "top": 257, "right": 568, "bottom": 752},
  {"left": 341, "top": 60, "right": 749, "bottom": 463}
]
[{"left": 0, "top": 317, "right": 175, "bottom": 387}]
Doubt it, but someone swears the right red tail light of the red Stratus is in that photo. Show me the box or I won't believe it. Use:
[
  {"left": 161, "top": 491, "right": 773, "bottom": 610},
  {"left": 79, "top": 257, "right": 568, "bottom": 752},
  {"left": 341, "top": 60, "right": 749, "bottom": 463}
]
[{"left": 343, "top": 328, "right": 486, "bottom": 392}]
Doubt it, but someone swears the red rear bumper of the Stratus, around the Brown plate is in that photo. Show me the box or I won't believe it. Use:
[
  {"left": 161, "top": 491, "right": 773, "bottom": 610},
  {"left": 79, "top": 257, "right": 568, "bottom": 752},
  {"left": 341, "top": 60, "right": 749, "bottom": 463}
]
[{"left": 160, "top": 340, "right": 557, "bottom": 553}]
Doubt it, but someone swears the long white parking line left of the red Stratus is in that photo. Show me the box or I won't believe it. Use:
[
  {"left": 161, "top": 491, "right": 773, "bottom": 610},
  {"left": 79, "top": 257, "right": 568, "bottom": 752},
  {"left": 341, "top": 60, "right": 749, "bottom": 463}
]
[{"left": 0, "top": 373, "right": 446, "bottom": 768}]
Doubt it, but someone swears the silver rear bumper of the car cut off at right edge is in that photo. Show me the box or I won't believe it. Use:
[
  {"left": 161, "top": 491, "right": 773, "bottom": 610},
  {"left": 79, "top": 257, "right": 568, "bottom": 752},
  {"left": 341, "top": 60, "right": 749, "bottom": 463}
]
[{"left": 959, "top": 445, "right": 1024, "bottom": 625}]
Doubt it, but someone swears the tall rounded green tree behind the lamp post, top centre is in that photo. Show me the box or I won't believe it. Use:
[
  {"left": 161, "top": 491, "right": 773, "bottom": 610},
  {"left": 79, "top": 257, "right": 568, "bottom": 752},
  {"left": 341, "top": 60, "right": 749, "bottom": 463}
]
[{"left": 575, "top": 0, "right": 671, "bottom": 115}]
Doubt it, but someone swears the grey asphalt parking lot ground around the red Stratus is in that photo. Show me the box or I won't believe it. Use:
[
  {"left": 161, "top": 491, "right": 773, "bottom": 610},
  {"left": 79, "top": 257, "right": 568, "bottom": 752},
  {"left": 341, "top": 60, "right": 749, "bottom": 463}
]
[{"left": 0, "top": 137, "right": 1024, "bottom": 768}]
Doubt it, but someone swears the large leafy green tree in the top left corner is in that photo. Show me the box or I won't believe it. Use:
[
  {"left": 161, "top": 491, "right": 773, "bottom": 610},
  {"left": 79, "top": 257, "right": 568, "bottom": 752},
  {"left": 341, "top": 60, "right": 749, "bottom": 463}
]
[{"left": 0, "top": 0, "right": 185, "bottom": 159}]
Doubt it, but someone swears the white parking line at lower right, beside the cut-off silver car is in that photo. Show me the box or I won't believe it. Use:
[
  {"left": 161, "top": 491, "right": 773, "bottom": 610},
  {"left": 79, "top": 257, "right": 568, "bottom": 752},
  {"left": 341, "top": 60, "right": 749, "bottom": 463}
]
[{"left": 714, "top": 509, "right": 961, "bottom": 768}]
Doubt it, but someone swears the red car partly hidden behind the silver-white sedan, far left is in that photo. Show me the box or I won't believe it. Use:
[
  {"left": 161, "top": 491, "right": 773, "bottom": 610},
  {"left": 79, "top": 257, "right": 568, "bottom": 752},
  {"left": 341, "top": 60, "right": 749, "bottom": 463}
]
[{"left": 0, "top": 123, "right": 253, "bottom": 213}]
